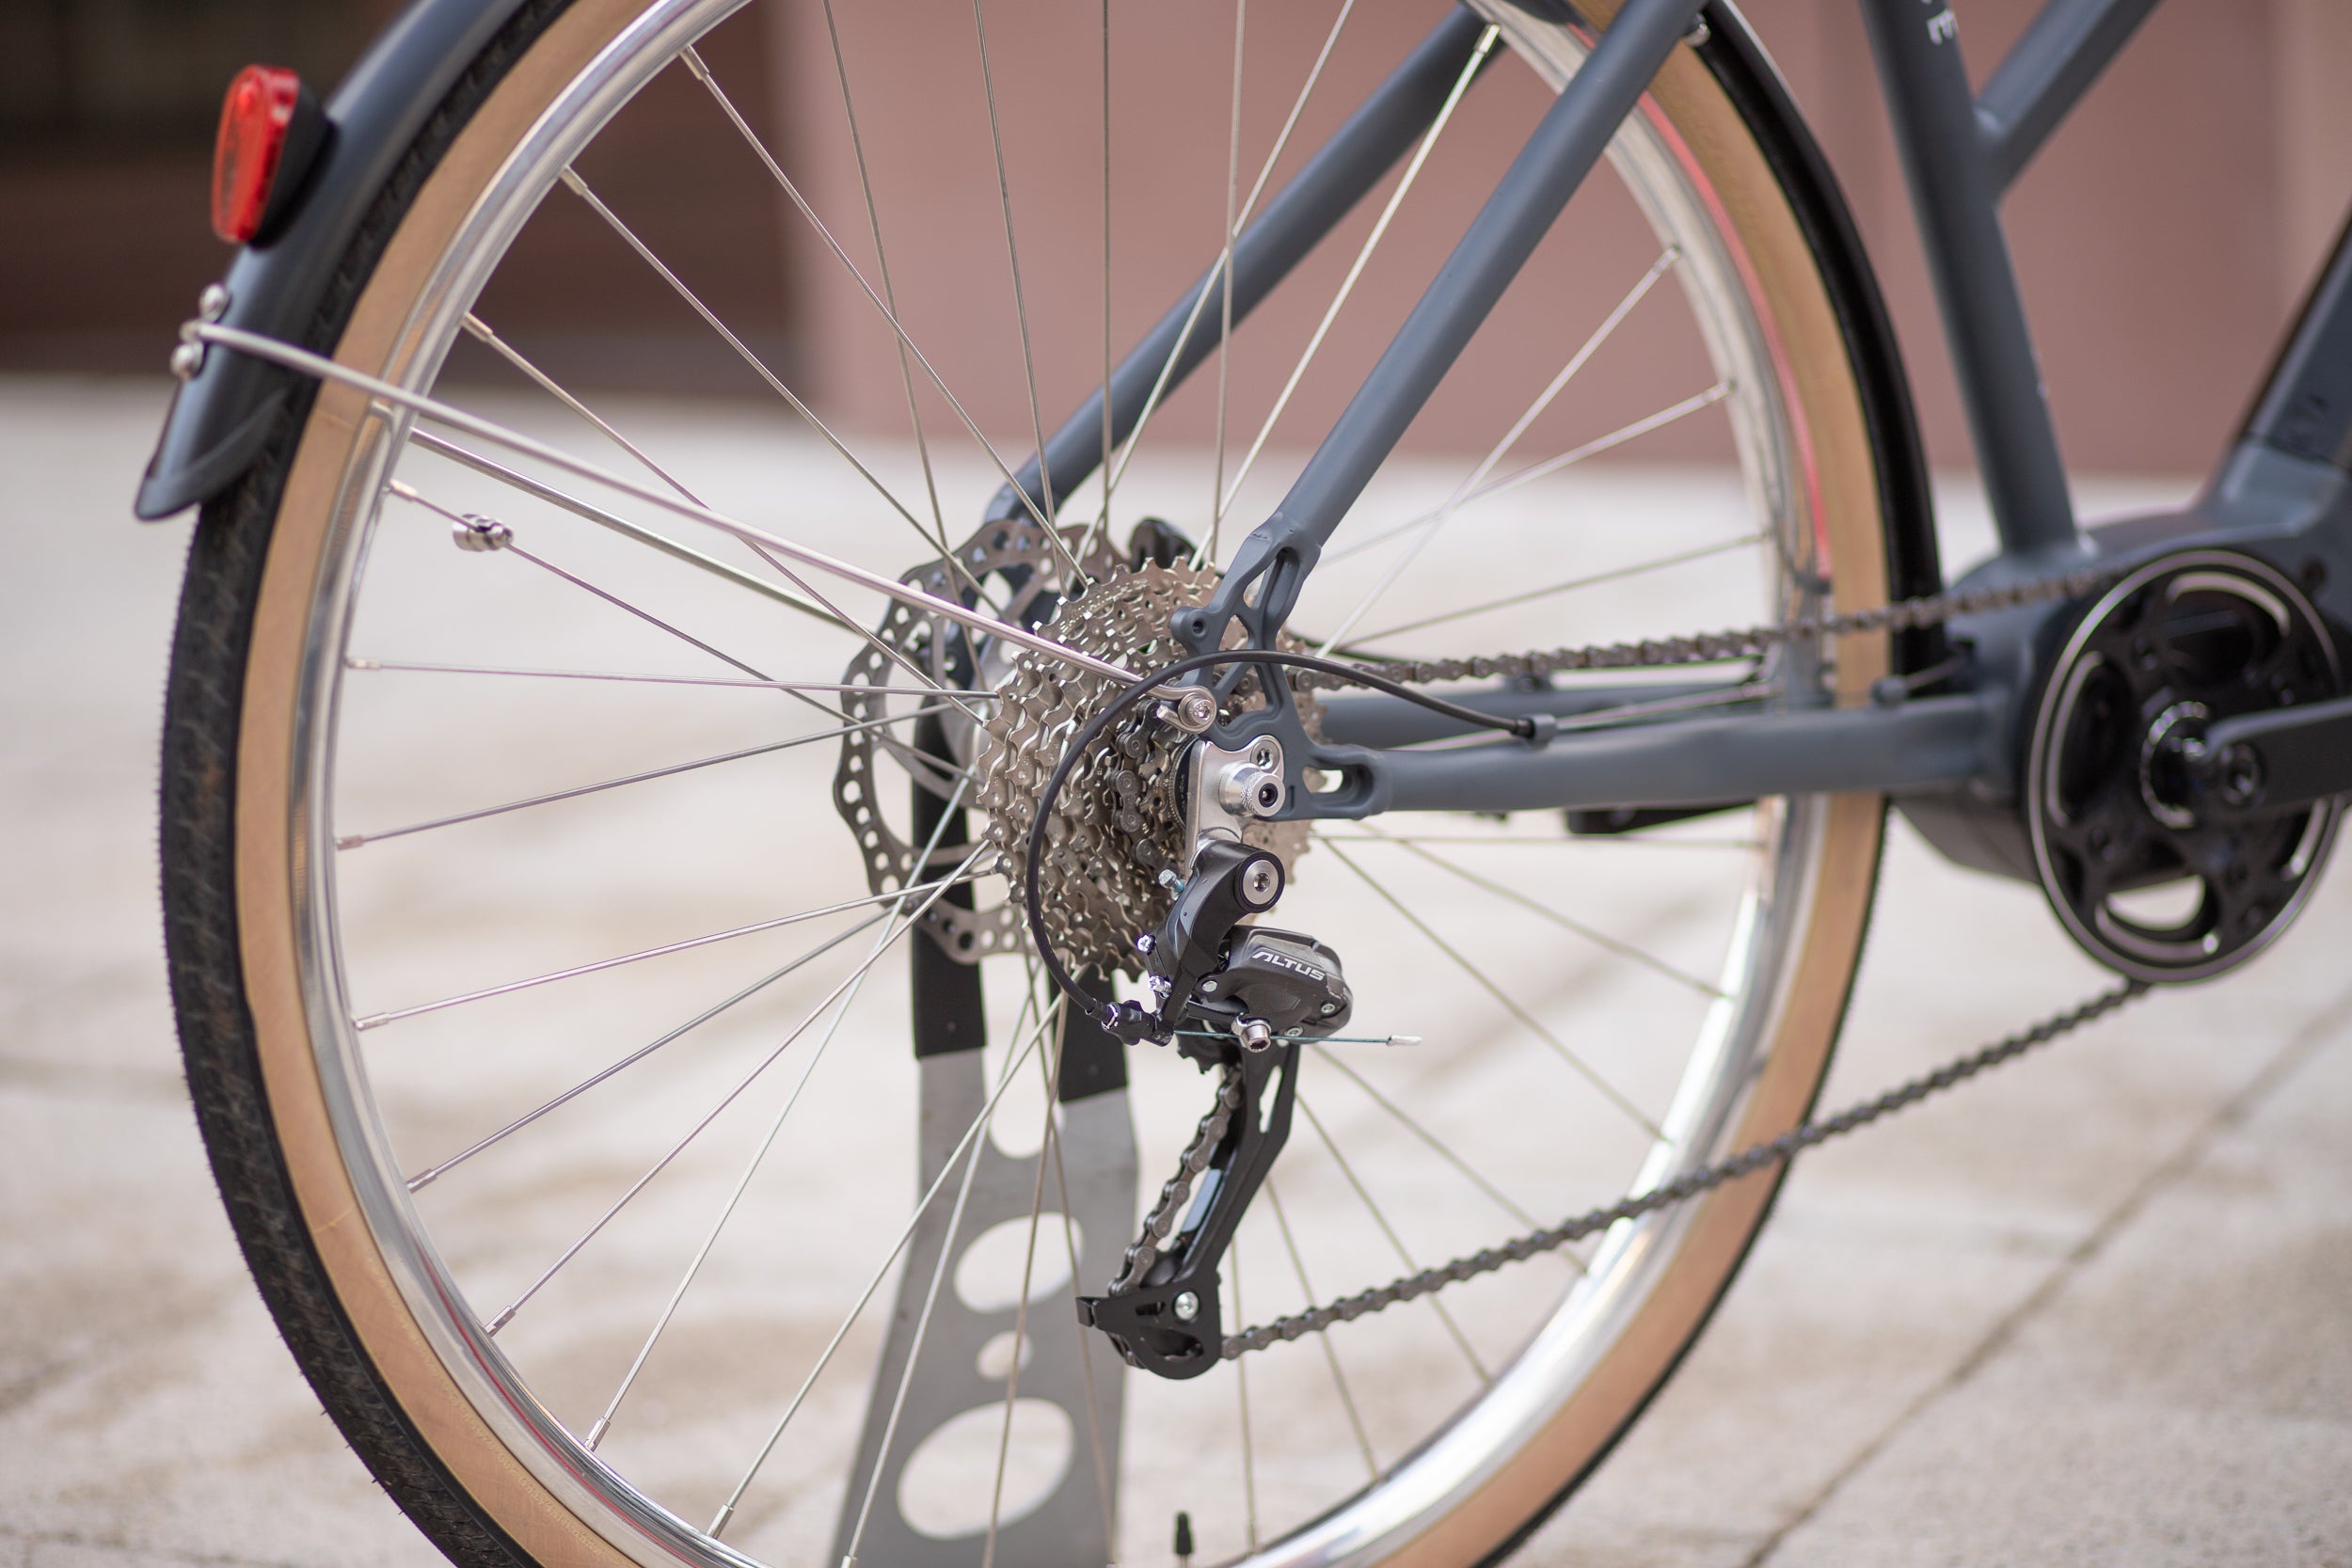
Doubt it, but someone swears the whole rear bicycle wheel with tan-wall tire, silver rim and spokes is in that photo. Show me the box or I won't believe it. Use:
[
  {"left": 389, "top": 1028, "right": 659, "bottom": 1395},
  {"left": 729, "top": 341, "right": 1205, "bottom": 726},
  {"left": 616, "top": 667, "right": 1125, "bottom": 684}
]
[{"left": 165, "top": 0, "right": 1891, "bottom": 1566}]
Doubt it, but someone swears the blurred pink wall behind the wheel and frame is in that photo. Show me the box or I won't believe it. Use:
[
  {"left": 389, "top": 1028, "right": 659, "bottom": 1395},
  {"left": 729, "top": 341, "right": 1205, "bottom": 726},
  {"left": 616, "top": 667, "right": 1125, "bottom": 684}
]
[{"left": 771, "top": 0, "right": 2352, "bottom": 472}]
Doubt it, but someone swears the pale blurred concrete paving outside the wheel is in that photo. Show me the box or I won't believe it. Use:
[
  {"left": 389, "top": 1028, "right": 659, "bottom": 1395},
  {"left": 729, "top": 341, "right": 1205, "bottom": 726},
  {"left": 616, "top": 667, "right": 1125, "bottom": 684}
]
[{"left": 0, "top": 381, "right": 2352, "bottom": 1568}]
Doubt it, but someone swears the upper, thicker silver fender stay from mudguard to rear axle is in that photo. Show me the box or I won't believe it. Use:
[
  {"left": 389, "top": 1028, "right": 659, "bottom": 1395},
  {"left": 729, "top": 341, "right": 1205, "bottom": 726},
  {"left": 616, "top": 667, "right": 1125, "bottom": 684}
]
[{"left": 188, "top": 322, "right": 1136, "bottom": 682}]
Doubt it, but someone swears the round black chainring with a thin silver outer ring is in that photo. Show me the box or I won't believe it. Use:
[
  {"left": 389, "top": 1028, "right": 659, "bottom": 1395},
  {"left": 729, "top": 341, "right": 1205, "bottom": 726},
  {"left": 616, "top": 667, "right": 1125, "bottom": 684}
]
[{"left": 2026, "top": 550, "right": 2343, "bottom": 980}]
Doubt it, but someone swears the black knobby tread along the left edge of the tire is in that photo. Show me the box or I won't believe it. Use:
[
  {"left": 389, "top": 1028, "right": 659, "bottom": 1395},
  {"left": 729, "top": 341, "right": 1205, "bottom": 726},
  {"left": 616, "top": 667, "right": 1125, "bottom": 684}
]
[{"left": 160, "top": 0, "right": 572, "bottom": 1568}]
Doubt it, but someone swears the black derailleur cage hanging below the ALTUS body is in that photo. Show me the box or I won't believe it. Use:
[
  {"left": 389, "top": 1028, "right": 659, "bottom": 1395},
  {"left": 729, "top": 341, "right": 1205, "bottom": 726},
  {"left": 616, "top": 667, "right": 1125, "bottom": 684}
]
[{"left": 1077, "top": 1039, "right": 1298, "bottom": 1378}]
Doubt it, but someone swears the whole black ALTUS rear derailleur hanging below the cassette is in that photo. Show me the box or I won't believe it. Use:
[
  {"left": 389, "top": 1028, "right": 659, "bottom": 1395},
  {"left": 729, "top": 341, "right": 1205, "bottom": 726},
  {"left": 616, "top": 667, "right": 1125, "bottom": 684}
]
[{"left": 1077, "top": 817, "right": 1355, "bottom": 1378}]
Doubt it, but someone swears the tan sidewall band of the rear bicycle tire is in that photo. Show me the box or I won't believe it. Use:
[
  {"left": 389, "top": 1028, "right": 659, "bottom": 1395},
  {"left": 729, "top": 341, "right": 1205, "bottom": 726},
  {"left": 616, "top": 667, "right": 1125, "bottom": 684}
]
[{"left": 235, "top": 0, "right": 1886, "bottom": 1568}]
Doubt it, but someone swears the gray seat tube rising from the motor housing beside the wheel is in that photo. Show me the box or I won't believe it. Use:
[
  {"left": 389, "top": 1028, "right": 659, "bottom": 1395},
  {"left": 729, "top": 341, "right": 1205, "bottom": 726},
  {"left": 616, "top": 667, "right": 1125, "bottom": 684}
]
[{"left": 1863, "top": 0, "right": 2084, "bottom": 557}]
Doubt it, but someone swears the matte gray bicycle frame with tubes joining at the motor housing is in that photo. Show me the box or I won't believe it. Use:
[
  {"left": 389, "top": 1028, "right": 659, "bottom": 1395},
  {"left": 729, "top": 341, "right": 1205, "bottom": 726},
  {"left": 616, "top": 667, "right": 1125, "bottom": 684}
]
[{"left": 991, "top": 0, "right": 2352, "bottom": 879}]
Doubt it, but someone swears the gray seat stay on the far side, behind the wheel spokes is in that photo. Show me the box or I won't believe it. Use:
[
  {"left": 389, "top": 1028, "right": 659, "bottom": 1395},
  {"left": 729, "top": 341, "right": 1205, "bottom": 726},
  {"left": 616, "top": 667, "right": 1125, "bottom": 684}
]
[{"left": 983, "top": 9, "right": 1486, "bottom": 522}]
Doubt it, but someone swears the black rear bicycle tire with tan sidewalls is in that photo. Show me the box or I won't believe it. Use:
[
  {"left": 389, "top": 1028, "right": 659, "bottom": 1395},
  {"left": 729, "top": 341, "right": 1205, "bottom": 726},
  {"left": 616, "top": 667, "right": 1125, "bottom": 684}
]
[{"left": 163, "top": 0, "right": 1933, "bottom": 1568}]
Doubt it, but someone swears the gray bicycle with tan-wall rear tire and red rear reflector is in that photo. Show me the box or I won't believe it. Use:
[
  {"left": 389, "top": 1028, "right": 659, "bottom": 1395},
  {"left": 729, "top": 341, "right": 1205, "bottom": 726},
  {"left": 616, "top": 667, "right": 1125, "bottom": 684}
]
[{"left": 139, "top": 0, "right": 2352, "bottom": 1566}]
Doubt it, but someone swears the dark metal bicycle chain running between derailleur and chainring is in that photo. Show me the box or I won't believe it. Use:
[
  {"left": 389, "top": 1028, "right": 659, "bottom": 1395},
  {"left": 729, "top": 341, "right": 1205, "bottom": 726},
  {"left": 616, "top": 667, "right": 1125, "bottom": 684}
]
[{"left": 1082, "top": 566, "right": 2148, "bottom": 1361}]
